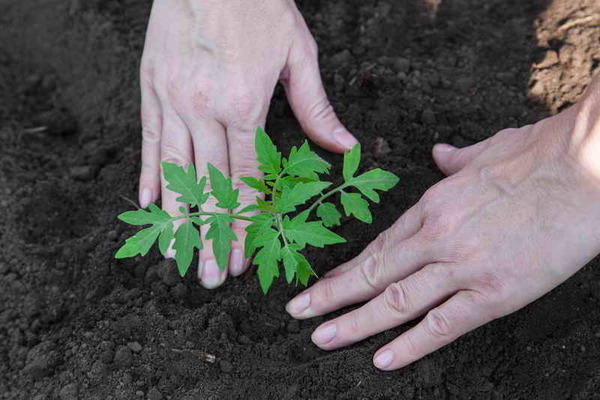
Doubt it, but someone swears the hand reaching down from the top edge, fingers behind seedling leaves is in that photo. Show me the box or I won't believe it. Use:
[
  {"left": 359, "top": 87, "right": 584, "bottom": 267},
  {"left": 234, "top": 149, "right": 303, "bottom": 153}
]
[{"left": 139, "top": 0, "right": 356, "bottom": 288}]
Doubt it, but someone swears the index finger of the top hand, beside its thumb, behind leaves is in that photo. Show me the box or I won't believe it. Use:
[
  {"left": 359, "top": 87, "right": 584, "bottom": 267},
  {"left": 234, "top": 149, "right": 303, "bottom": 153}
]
[{"left": 227, "top": 121, "right": 264, "bottom": 276}]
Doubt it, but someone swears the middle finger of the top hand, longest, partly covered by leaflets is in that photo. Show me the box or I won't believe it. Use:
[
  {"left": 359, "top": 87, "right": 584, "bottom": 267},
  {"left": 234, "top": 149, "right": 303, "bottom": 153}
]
[{"left": 188, "top": 119, "right": 229, "bottom": 289}]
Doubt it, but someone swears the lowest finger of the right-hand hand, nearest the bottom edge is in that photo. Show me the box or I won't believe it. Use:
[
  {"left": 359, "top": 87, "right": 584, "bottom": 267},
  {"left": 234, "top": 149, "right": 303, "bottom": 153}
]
[{"left": 373, "top": 290, "right": 495, "bottom": 371}]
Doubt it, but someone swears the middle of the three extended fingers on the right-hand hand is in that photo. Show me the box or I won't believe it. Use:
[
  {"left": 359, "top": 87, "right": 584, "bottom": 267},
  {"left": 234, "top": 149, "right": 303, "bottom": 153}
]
[{"left": 312, "top": 263, "right": 461, "bottom": 350}]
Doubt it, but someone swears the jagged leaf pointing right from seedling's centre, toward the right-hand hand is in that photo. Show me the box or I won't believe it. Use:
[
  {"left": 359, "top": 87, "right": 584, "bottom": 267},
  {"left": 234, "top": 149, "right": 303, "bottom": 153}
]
[{"left": 283, "top": 212, "right": 346, "bottom": 248}]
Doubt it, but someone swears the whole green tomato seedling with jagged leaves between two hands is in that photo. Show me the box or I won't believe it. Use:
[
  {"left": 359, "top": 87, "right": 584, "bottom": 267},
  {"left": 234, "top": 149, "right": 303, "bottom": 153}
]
[{"left": 115, "top": 128, "right": 398, "bottom": 293}]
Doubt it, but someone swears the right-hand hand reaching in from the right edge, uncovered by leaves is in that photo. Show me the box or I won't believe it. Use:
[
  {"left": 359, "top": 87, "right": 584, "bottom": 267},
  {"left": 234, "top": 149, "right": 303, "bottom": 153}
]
[{"left": 286, "top": 86, "right": 600, "bottom": 370}]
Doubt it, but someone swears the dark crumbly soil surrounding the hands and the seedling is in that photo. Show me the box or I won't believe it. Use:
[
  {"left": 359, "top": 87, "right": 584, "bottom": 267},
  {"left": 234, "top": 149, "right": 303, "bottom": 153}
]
[{"left": 0, "top": 0, "right": 600, "bottom": 400}]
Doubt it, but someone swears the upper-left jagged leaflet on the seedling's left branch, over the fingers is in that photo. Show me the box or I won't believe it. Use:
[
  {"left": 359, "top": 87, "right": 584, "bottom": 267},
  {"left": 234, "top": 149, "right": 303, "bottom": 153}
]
[{"left": 161, "top": 162, "right": 209, "bottom": 207}]
